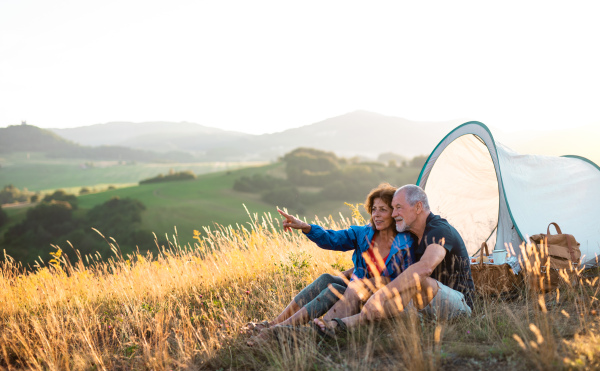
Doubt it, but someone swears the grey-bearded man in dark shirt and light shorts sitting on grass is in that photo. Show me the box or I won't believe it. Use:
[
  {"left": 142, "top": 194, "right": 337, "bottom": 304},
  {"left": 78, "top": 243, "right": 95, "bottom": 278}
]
[{"left": 315, "top": 184, "right": 474, "bottom": 332}]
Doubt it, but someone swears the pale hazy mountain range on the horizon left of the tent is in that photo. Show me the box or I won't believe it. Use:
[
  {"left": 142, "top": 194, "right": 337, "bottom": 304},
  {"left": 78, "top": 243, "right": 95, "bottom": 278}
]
[{"left": 51, "top": 111, "right": 460, "bottom": 161}]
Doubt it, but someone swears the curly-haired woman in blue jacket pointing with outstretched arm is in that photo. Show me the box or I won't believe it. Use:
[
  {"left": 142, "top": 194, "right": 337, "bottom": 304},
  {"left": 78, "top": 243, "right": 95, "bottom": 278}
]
[{"left": 248, "top": 183, "right": 413, "bottom": 346}]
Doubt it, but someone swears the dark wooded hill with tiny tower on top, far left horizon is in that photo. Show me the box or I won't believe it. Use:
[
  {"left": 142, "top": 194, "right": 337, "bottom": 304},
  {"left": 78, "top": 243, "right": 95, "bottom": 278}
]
[{"left": 0, "top": 125, "right": 195, "bottom": 162}]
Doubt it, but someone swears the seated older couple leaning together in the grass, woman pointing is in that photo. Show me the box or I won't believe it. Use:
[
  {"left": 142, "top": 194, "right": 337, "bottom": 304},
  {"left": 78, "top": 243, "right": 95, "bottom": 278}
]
[{"left": 248, "top": 183, "right": 474, "bottom": 346}]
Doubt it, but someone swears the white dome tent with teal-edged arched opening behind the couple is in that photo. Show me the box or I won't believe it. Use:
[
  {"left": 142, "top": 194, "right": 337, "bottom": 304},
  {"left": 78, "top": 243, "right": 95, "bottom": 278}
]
[{"left": 417, "top": 121, "right": 600, "bottom": 266}]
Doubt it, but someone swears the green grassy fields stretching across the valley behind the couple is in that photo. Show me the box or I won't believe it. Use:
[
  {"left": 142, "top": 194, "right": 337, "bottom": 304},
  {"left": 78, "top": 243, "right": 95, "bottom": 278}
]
[{"left": 0, "top": 158, "right": 418, "bottom": 258}]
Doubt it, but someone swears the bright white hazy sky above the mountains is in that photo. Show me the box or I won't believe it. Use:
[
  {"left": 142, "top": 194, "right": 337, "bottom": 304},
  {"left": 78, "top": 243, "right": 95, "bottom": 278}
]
[{"left": 0, "top": 0, "right": 600, "bottom": 133}]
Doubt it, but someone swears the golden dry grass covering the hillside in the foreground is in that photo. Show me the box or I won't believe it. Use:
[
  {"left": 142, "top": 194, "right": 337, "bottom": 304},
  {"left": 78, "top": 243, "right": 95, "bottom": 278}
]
[{"left": 0, "top": 211, "right": 600, "bottom": 370}]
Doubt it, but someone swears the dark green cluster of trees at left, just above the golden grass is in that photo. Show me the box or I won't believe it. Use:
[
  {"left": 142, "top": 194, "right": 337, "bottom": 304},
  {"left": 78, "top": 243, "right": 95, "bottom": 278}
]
[{"left": 0, "top": 190, "right": 155, "bottom": 266}]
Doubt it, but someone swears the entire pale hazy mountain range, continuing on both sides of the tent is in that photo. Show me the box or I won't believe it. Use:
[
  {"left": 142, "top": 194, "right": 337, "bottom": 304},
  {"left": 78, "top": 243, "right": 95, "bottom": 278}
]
[{"left": 41, "top": 111, "right": 600, "bottom": 163}]
